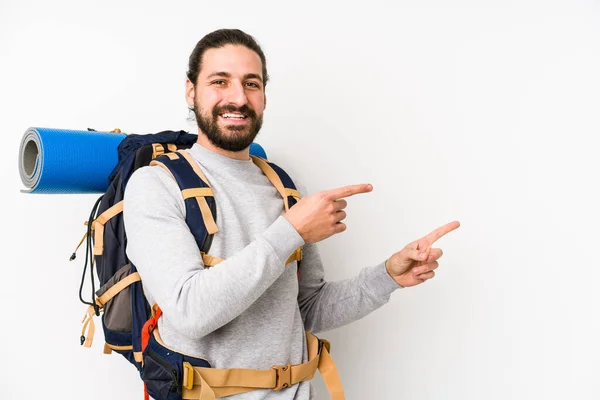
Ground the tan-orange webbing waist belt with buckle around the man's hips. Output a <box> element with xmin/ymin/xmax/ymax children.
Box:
<box><xmin>182</xmin><ymin>332</ymin><xmax>345</xmax><ymax>400</ymax></box>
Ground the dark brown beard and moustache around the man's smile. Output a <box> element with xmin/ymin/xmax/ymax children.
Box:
<box><xmin>194</xmin><ymin>100</ymin><xmax>262</xmax><ymax>152</ymax></box>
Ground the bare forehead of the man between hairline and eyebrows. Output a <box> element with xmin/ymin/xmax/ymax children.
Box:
<box><xmin>200</xmin><ymin>45</ymin><xmax>262</xmax><ymax>76</ymax></box>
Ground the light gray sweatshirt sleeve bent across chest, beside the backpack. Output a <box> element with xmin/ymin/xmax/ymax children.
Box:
<box><xmin>123</xmin><ymin>167</ymin><xmax>304</xmax><ymax>339</ymax></box>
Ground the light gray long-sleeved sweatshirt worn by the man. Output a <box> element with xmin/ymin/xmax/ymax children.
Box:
<box><xmin>123</xmin><ymin>144</ymin><xmax>400</xmax><ymax>400</ymax></box>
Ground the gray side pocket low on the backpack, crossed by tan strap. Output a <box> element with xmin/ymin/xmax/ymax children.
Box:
<box><xmin>96</xmin><ymin>263</ymin><xmax>131</xmax><ymax>332</ymax></box>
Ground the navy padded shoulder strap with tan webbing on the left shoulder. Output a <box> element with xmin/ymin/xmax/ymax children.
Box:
<box><xmin>150</xmin><ymin>151</ymin><xmax>219</xmax><ymax>253</ymax></box>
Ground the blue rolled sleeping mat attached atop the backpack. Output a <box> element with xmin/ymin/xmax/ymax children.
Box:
<box><xmin>19</xmin><ymin>127</ymin><xmax>267</xmax><ymax>194</ymax></box>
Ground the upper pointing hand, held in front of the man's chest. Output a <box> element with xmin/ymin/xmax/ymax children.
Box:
<box><xmin>284</xmin><ymin>184</ymin><xmax>373</xmax><ymax>243</ymax></box>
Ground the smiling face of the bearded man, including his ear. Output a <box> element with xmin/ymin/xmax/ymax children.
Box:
<box><xmin>186</xmin><ymin>45</ymin><xmax>266</xmax><ymax>151</ymax></box>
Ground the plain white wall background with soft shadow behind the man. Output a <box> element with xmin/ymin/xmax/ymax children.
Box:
<box><xmin>0</xmin><ymin>0</ymin><xmax>600</xmax><ymax>400</ymax></box>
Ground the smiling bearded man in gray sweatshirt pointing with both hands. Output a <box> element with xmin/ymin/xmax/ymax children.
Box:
<box><xmin>124</xmin><ymin>30</ymin><xmax>459</xmax><ymax>399</ymax></box>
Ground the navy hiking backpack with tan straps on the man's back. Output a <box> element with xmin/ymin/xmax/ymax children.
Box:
<box><xmin>71</xmin><ymin>131</ymin><xmax>343</xmax><ymax>400</ymax></box>
